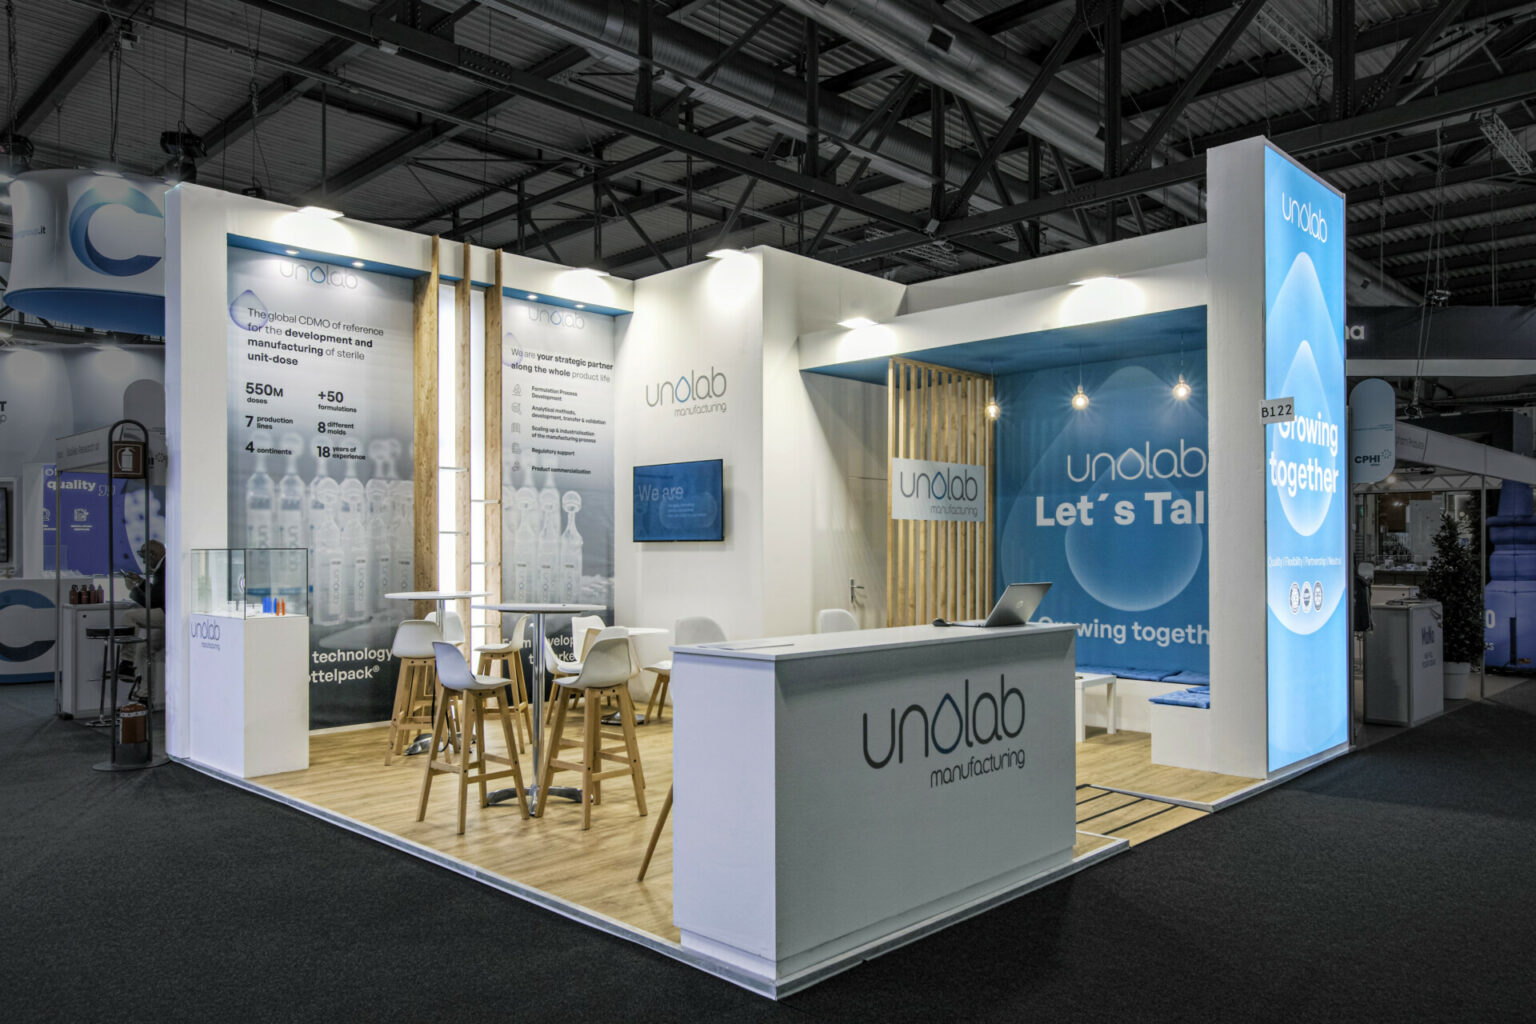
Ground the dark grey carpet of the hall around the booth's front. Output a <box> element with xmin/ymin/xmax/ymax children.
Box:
<box><xmin>0</xmin><ymin>683</ymin><xmax>1536</xmax><ymax>1024</ymax></box>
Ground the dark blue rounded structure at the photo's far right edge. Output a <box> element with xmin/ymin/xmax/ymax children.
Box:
<box><xmin>1484</xmin><ymin>481</ymin><xmax>1536</xmax><ymax>668</ymax></box>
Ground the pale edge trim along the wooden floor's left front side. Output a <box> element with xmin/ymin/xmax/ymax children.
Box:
<box><xmin>170</xmin><ymin>757</ymin><xmax>774</xmax><ymax>998</ymax></box>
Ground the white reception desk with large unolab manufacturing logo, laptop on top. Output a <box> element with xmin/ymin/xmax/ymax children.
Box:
<box><xmin>671</xmin><ymin>625</ymin><xmax>1075</xmax><ymax>995</ymax></box>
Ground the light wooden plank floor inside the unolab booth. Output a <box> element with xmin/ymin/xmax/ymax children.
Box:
<box><xmin>255</xmin><ymin>715</ymin><xmax>1234</xmax><ymax>941</ymax></box>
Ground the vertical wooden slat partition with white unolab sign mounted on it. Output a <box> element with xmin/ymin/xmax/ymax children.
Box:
<box><xmin>885</xmin><ymin>359</ymin><xmax>994</xmax><ymax>626</ymax></box>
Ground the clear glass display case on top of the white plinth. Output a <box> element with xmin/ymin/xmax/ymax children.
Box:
<box><xmin>192</xmin><ymin>548</ymin><xmax>309</xmax><ymax>619</ymax></box>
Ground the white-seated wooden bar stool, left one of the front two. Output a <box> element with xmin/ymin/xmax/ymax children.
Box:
<box><xmin>416</xmin><ymin>640</ymin><xmax>528</xmax><ymax>835</ymax></box>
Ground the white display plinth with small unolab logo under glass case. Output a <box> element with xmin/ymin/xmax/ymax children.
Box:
<box><xmin>187</xmin><ymin>616</ymin><xmax>309</xmax><ymax>778</ymax></box>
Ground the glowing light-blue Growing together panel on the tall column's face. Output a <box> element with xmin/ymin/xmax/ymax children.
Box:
<box><xmin>1264</xmin><ymin>149</ymin><xmax>1349</xmax><ymax>771</ymax></box>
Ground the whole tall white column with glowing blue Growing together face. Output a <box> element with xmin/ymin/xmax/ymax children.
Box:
<box><xmin>1207</xmin><ymin>138</ymin><xmax>1349</xmax><ymax>778</ymax></box>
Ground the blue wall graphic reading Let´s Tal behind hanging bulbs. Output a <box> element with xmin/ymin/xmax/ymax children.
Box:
<box><xmin>995</xmin><ymin>354</ymin><xmax>1210</xmax><ymax>674</ymax></box>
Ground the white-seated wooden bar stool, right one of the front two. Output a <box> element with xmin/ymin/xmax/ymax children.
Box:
<box><xmin>535</xmin><ymin>629</ymin><xmax>645</xmax><ymax>829</ymax></box>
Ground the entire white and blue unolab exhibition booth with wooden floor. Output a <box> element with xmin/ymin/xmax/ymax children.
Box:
<box><xmin>5</xmin><ymin>138</ymin><xmax>1350</xmax><ymax>996</ymax></box>
